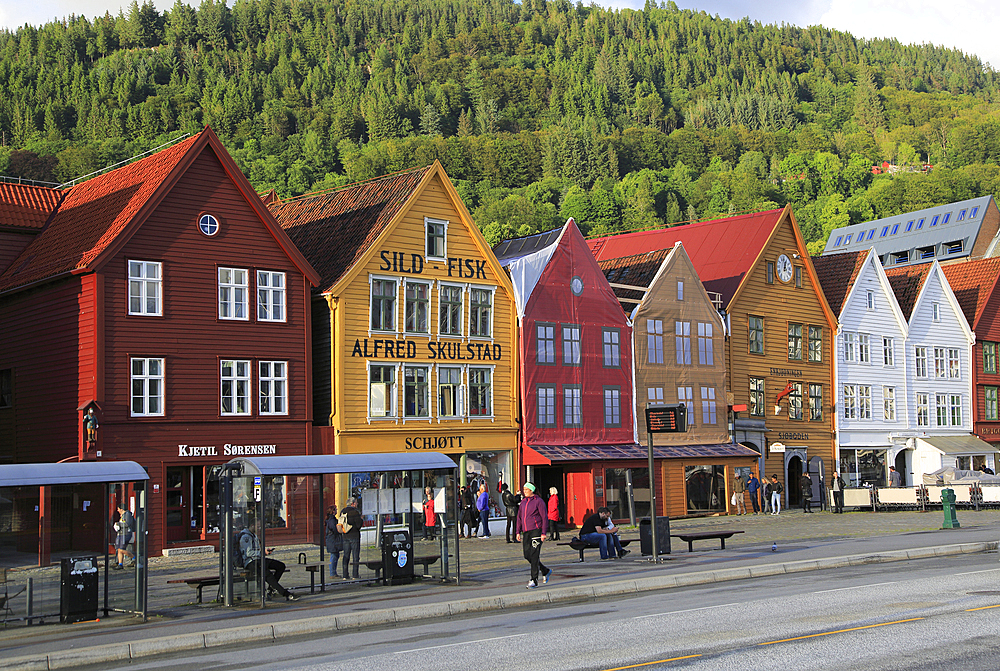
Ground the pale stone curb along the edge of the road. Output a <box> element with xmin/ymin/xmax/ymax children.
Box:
<box><xmin>0</xmin><ymin>541</ymin><xmax>1000</xmax><ymax>671</ymax></box>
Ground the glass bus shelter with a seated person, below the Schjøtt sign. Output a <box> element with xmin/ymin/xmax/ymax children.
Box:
<box><xmin>219</xmin><ymin>452</ymin><xmax>461</xmax><ymax>608</ymax></box>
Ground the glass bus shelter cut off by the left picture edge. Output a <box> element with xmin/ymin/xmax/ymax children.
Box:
<box><xmin>0</xmin><ymin>461</ymin><xmax>149</xmax><ymax>626</ymax></box>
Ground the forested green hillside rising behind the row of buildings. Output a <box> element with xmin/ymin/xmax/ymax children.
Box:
<box><xmin>0</xmin><ymin>0</ymin><xmax>1000</xmax><ymax>252</ymax></box>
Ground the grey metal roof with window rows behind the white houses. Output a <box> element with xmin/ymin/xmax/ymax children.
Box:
<box><xmin>823</xmin><ymin>196</ymin><xmax>993</xmax><ymax>266</ymax></box>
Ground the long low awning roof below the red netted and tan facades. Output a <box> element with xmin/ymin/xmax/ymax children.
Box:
<box><xmin>522</xmin><ymin>443</ymin><xmax>760</xmax><ymax>466</ymax></box>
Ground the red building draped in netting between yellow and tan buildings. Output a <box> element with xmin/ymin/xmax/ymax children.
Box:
<box><xmin>494</xmin><ymin>219</ymin><xmax>636</xmax><ymax>524</ymax></box>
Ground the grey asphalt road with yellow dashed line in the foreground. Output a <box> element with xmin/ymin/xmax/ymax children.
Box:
<box><xmin>74</xmin><ymin>553</ymin><xmax>1000</xmax><ymax>671</ymax></box>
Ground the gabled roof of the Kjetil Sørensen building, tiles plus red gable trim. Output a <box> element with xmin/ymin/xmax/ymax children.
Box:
<box><xmin>0</xmin><ymin>127</ymin><xmax>318</xmax><ymax>292</ymax></box>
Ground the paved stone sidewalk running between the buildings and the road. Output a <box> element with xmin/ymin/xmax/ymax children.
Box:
<box><xmin>0</xmin><ymin>510</ymin><xmax>1000</xmax><ymax>669</ymax></box>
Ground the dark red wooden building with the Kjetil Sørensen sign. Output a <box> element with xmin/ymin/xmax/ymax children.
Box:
<box><xmin>0</xmin><ymin>128</ymin><xmax>318</xmax><ymax>554</ymax></box>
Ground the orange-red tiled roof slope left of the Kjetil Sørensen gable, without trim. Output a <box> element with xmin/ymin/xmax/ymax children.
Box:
<box><xmin>0</xmin><ymin>133</ymin><xmax>201</xmax><ymax>291</ymax></box>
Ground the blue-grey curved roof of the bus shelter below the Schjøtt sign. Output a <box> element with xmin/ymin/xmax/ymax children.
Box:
<box><xmin>229</xmin><ymin>452</ymin><xmax>458</xmax><ymax>475</ymax></box>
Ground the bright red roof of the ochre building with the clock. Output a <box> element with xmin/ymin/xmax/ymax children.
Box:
<box><xmin>588</xmin><ymin>210</ymin><xmax>785</xmax><ymax>306</ymax></box>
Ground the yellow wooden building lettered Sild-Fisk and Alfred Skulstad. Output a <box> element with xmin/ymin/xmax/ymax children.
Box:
<box><xmin>270</xmin><ymin>161</ymin><xmax>519</xmax><ymax>501</ymax></box>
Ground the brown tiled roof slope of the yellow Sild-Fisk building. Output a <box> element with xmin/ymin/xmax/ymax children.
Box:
<box><xmin>268</xmin><ymin>164</ymin><xmax>434</xmax><ymax>293</ymax></box>
